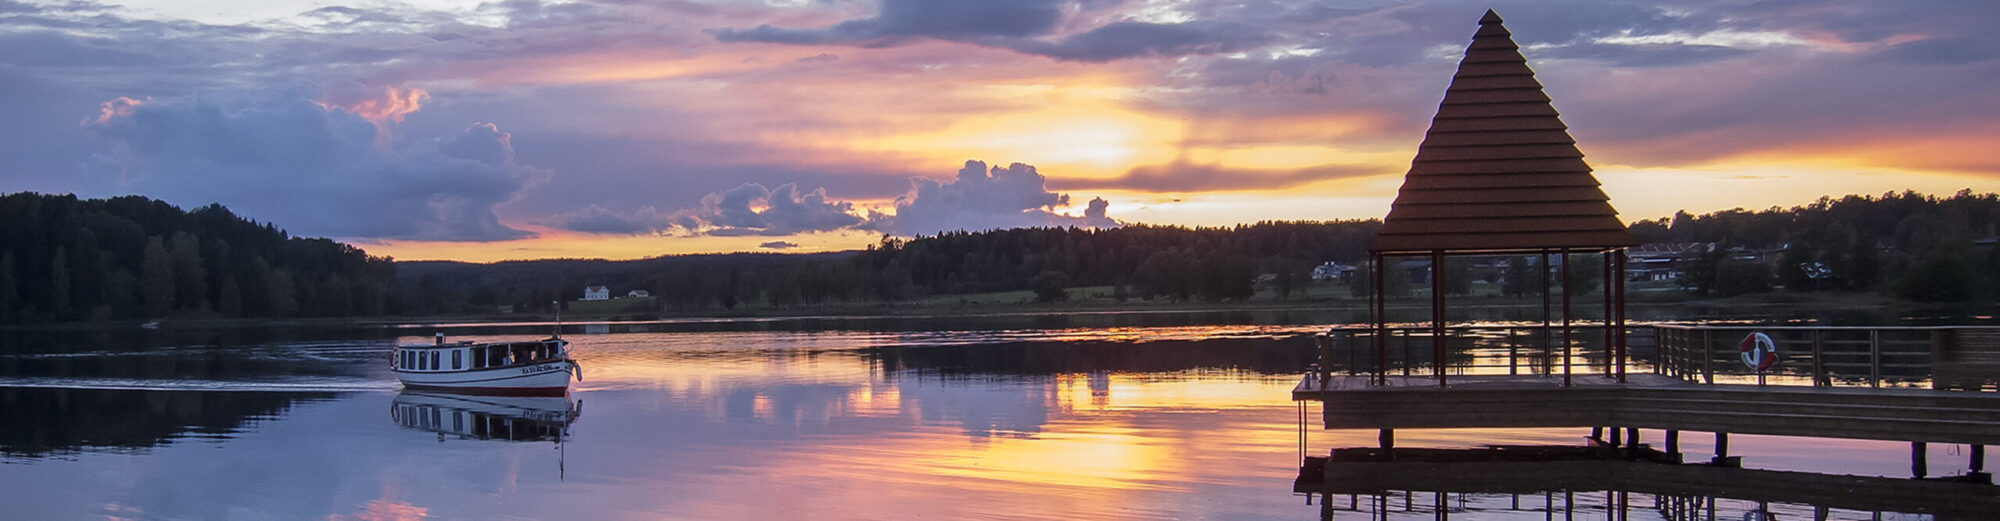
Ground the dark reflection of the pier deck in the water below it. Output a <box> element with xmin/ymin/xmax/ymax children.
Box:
<box><xmin>1292</xmin><ymin>447</ymin><xmax>2000</xmax><ymax>521</ymax></box>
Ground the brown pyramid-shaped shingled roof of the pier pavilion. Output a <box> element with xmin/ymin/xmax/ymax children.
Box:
<box><xmin>1374</xmin><ymin>10</ymin><xmax>1636</xmax><ymax>252</ymax></box>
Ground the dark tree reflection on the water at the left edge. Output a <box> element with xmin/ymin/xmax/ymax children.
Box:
<box><xmin>0</xmin><ymin>387</ymin><xmax>334</xmax><ymax>457</ymax></box>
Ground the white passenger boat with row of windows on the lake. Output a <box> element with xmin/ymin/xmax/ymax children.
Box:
<box><xmin>390</xmin><ymin>333</ymin><xmax>584</xmax><ymax>395</ymax></box>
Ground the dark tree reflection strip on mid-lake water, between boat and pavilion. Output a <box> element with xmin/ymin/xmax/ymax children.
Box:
<box><xmin>866</xmin><ymin>335</ymin><xmax>1314</xmax><ymax>377</ymax></box>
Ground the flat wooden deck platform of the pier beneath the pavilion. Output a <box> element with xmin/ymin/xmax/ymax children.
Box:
<box><xmin>1292</xmin><ymin>375</ymin><xmax>2000</xmax><ymax>445</ymax></box>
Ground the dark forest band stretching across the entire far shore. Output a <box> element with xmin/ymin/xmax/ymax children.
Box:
<box><xmin>0</xmin><ymin>190</ymin><xmax>2000</xmax><ymax>323</ymax></box>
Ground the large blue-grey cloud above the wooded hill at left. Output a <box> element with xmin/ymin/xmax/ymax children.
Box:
<box><xmin>84</xmin><ymin>92</ymin><xmax>546</xmax><ymax>240</ymax></box>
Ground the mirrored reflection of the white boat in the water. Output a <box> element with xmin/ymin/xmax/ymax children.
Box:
<box><xmin>388</xmin><ymin>391</ymin><xmax>584</xmax><ymax>445</ymax></box>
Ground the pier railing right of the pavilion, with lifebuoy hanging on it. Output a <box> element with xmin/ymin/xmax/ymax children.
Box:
<box><xmin>1650</xmin><ymin>325</ymin><xmax>2000</xmax><ymax>391</ymax></box>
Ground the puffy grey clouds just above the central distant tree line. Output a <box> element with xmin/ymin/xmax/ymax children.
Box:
<box><xmin>540</xmin><ymin>160</ymin><xmax>1120</xmax><ymax>238</ymax></box>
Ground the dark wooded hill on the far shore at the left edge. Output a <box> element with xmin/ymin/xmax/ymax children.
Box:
<box><xmin>0</xmin><ymin>192</ymin><xmax>396</xmax><ymax>323</ymax></box>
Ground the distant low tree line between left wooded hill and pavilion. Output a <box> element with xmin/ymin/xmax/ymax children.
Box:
<box><xmin>398</xmin><ymin>220</ymin><xmax>1380</xmax><ymax>315</ymax></box>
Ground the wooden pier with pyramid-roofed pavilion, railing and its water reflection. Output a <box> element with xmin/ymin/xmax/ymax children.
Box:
<box><xmin>1292</xmin><ymin>10</ymin><xmax>2000</xmax><ymax>519</ymax></box>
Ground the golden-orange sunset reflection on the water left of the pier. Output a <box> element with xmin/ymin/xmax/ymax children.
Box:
<box><xmin>552</xmin><ymin>329</ymin><xmax>1296</xmax><ymax>519</ymax></box>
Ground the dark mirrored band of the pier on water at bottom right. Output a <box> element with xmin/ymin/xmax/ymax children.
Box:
<box><xmin>1294</xmin><ymin>452</ymin><xmax>2000</xmax><ymax>521</ymax></box>
